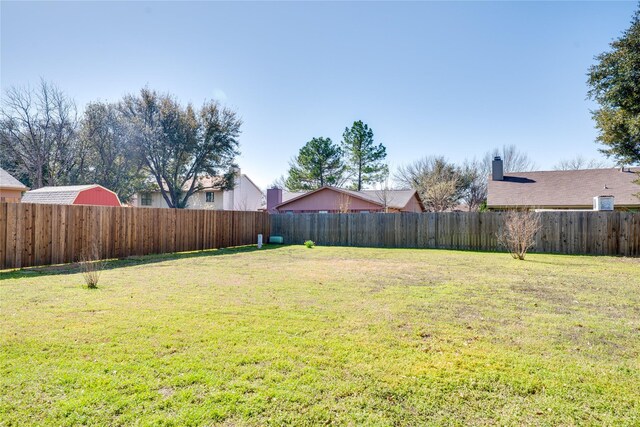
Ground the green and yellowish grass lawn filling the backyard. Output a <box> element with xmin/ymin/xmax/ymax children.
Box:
<box><xmin>0</xmin><ymin>246</ymin><xmax>640</xmax><ymax>426</ymax></box>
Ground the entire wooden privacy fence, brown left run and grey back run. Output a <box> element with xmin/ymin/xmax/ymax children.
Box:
<box><xmin>0</xmin><ymin>203</ymin><xmax>640</xmax><ymax>268</ymax></box>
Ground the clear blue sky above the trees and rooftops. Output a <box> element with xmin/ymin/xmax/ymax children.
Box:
<box><xmin>0</xmin><ymin>1</ymin><xmax>637</xmax><ymax>186</ymax></box>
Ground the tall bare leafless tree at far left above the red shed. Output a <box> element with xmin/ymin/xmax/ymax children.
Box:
<box><xmin>0</xmin><ymin>80</ymin><xmax>84</xmax><ymax>188</ymax></box>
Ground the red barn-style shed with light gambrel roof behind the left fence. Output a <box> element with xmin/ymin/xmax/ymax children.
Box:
<box><xmin>22</xmin><ymin>184</ymin><xmax>122</xmax><ymax>206</ymax></box>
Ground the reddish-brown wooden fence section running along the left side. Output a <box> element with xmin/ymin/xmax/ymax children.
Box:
<box><xmin>0</xmin><ymin>203</ymin><xmax>269</xmax><ymax>268</ymax></box>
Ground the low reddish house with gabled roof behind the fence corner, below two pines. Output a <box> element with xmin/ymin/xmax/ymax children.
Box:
<box><xmin>267</xmin><ymin>187</ymin><xmax>424</xmax><ymax>213</ymax></box>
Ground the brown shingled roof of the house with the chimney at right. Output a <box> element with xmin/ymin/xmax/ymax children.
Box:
<box><xmin>487</xmin><ymin>168</ymin><xmax>640</xmax><ymax>208</ymax></box>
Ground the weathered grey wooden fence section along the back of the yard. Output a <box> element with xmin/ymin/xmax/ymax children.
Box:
<box><xmin>271</xmin><ymin>212</ymin><xmax>640</xmax><ymax>256</ymax></box>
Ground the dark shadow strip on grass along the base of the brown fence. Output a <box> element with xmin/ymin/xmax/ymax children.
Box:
<box><xmin>0</xmin><ymin>245</ymin><xmax>284</xmax><ymax>280</ymax></box>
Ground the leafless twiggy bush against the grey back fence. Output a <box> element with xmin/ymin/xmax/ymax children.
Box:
<box><xmin>499</xmin><ymin>209</ymin><xmax>542</xmax><ymax>260</ymax></box>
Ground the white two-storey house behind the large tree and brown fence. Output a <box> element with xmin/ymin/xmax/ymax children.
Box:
<box><xmin>131</xmin><ymin>171</ymin><xmax>264</xmax><ymax>211</ymax></box>
